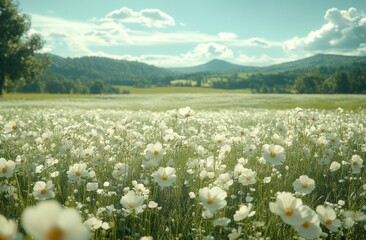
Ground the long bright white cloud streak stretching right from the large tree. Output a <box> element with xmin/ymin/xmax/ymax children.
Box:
<box><xmin>32</xmin><ymin>13</ymin><xmax>280</xmax><ymax>56</ymax></box>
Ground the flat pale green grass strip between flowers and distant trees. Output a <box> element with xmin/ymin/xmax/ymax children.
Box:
<box><xmin>0</xmin><ymin>92</ymin><xmax>366</xmax><ymax>111</ymax></box>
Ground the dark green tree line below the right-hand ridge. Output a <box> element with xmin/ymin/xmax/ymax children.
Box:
<box><xmin>189</xmin><ymin>63</ymin><xmax>366</xmax><ymax>94</ymax></box>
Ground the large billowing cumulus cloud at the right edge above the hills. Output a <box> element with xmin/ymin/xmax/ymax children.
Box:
<box><xmin>284</xmin><ymin>8</ymin><xmax>366</xmax><ymax>55</ymax></box>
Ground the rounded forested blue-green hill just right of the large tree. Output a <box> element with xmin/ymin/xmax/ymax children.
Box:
<box><xmin>47</xmin><ymin>55</ymin><xmax>174</xmax><ymax>85</ymax></box>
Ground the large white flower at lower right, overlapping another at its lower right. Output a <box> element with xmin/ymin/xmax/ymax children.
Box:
<box><xmin>269</xmin><ymin>192</ymin><xmax>309</xmax><ymax>226</ymax></box>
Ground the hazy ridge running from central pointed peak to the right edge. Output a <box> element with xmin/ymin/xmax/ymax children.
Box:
<box><xmin>170</xmin><ymin>54</ymin><xmax>366</xmax><ymax>73</ymax></box>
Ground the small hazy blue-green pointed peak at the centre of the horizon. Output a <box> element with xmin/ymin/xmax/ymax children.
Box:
<box><xmin>170</xmin><ymin>59</ymin><xmax>258</xmax><ymax>73</ymax></box>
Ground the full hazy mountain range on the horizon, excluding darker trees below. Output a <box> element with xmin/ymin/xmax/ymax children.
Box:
<box><xmin>38</xmin><ymin>54</ymin><xmax>366</xmax><ymax>86</ymax></box>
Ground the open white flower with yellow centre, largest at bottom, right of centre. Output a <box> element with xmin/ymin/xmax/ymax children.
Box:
<box><xmin>199</xmin><ymin>187</ymin><xmax>227</xmax><ymax>213</ymax></box>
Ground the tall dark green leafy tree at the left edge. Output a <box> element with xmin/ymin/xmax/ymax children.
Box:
<box><xmin>0</xmin><ymin>0</ymin><xmax>48</xmax><ymax>95</ymax></box>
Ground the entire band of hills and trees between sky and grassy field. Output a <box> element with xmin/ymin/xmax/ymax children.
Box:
<box><xmin>13</xmin><ymin>54</ymin><xmax>366</xmax><ymax>94</ymax></box>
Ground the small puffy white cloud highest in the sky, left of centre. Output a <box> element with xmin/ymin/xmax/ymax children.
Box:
<box><xmin>104</xmin><ymin>7</ymin><xmax>175</xmax><ymax>28</ymax></box>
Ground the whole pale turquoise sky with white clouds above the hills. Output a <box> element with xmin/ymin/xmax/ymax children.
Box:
<box><xmin>18</xmin><ymin>0</ymin><xmax>366</xmax><ymax>67</ymax></box>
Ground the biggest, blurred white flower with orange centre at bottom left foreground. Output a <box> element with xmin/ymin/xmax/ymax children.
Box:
<box><xmin>21</xmin><ymin>201</ymin><xmax>89</xmax><ymax>240</ymax></box>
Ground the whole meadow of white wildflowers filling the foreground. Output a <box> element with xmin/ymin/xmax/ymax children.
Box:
<box><xmin>0</xmin><ymin>103</ymin><xmax>366</xmax><ymax>240</ymax></box>
